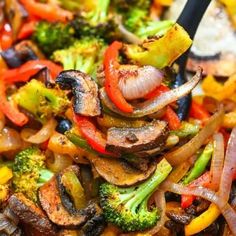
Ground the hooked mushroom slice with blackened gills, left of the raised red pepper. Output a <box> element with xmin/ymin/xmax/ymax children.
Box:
<box><xmin>56</xmin><ymin>70</ymin><xmax>101</xmax><ymax>116</ymax></box>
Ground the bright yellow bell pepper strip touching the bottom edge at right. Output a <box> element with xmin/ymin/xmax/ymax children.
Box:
<box><xmin>184</xmin><ymin>203</ymin><xmax>221</xmax><ymax>235</ymax></box>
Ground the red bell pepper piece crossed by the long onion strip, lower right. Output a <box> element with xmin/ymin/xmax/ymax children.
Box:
<box><xmin>181</xmin><ymin>171</ymin><xmax>211</xmax><ymax>209</ymax></box>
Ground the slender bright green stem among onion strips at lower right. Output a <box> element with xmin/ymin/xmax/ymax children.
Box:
<box><xmin>183</xmin><ymin>143</ymin><xmax>214</xmax><ymax>185</ymax></box>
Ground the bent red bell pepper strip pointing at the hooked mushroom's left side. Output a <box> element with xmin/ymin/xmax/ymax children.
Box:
<box><xmin>3</xmin><ymin>60</ymin><xmax>62</xmax><ymax>84</ymax></box>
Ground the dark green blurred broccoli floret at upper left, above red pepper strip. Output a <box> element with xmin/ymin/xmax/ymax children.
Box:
<box><xmin>33</xmin><ymin>21</ymin><xmax>74</xmax><ymax>56</ymax></box>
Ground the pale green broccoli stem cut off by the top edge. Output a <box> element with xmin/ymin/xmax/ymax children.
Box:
<box><xmin>90</xmin><ymin>0</ymin><xmax>110</xmax><ymax>25</ymax></box>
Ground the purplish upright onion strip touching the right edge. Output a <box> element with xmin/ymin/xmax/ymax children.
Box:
<box><xmin>219</xmin><ymin>127</ymin><xmax>236</xmax><ymax>203</ymax></box>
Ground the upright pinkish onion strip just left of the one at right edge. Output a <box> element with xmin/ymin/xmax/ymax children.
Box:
<box><xmin>210</xmin><ymin>133</ymin><xmax>224</xmax><ymax>191</ymax></box>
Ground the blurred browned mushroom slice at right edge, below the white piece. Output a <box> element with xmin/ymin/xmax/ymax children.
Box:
<box><xmin>187</xmin><ymin>53</ymin><xmax>236</xmax><ymax>77</ymax></box>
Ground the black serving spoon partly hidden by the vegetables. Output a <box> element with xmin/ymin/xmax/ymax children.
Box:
<box><xmin>173</xmin><ymin>0</ymin><xmax>211</xmax><ymax>120</ymax></box>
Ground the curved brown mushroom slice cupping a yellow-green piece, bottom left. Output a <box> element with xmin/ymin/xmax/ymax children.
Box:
<box><xmin>39</xmin><ymin>172</ymin><xmax>95</xmax><ymax>229</ymax></box>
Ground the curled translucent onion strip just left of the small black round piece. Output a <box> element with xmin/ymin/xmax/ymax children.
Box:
<box><xmin>21</xmin><ymin>119</ymin><xmax>57</xmax><ymax>144</ymax></box>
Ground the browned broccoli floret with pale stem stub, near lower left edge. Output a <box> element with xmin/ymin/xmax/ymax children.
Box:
<box><xmin>13</xmin><ymin>147</ymin><xmax>53</xmax><ymax>202</ymax></box>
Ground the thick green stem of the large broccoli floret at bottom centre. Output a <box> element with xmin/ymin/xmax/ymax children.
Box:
<box><xmin>125</xmin><ymin>159</ymin><xmax>172</xmax><ymax>210</ymax></box>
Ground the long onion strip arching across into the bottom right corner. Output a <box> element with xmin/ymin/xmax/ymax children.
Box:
<box><xmin>160</xmin><ymin>181</ymin><xmax>236</xmax><ymax>235</ymax></box>
